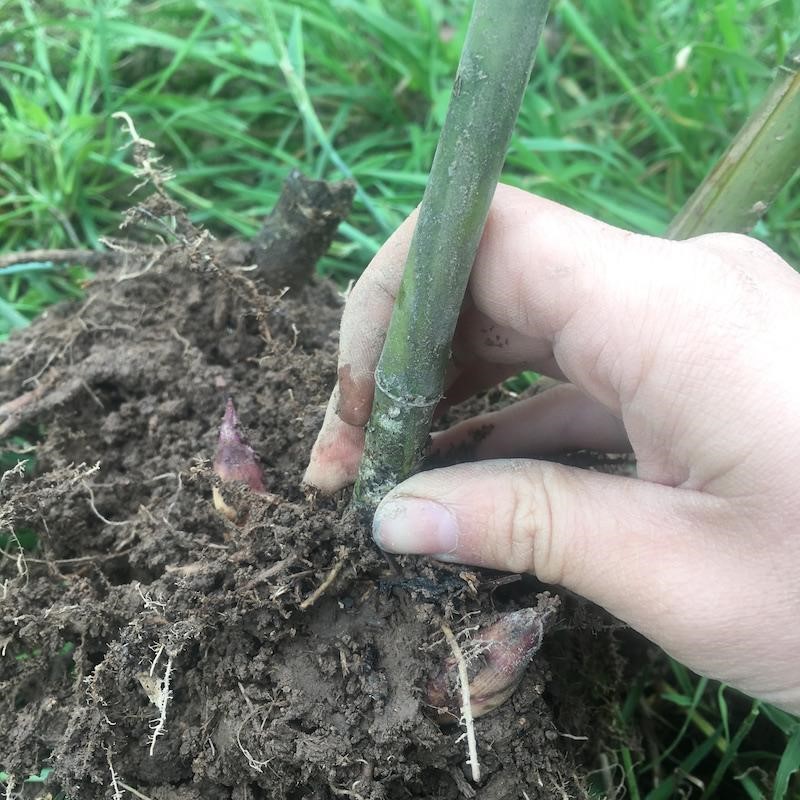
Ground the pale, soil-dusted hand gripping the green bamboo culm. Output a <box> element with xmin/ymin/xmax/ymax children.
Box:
<box><xmin>306</xmin><ymin>186</ymin><xmax>800</xmax><ymax>713</ymax></box>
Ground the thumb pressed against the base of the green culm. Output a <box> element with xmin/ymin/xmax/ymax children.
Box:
<box><xmin>373</xmin><ymin>461</ymin><xmax>800</xmax><ymax>703</ymax></box>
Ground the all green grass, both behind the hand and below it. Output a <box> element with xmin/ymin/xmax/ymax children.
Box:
<box><xmin>0</xmin><ymin>0</ymin><xmax>800</xmax><ymax>800</ymax></box>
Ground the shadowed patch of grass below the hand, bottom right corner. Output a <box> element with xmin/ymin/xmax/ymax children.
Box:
<box><xmin>617</xmin><ymin>659</ymin><xmax>800</xmax><ymax>800</ymax></box>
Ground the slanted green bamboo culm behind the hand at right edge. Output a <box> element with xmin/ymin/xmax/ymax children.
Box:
<box><xmin>667</xmin><ymin>40</ymin><xmax>800</xmax><ymax>239</ymax></box>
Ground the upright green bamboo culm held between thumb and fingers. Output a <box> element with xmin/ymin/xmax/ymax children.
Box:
<box><xmin>353</xmin><ymin>0</ymin><xmax>549</xmax><ymax>513</ymax></box>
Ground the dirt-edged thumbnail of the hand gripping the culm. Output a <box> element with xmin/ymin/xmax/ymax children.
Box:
<box><xmin>372</xmin><ymin>497</ymin><xmax>458</xmax><ymax>556</ymax></box>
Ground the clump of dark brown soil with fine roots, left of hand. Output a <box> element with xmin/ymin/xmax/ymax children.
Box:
<box><xmin>0</xmin><ymin>177</ymin><xmax>621</xmax><ymax>800</ymax></box>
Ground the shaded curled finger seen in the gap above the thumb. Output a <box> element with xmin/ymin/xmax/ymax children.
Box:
<box><xmin>432</xmin><ymin>384</ymin><xmax>630</xmax><ymax>460</ymax></box>
